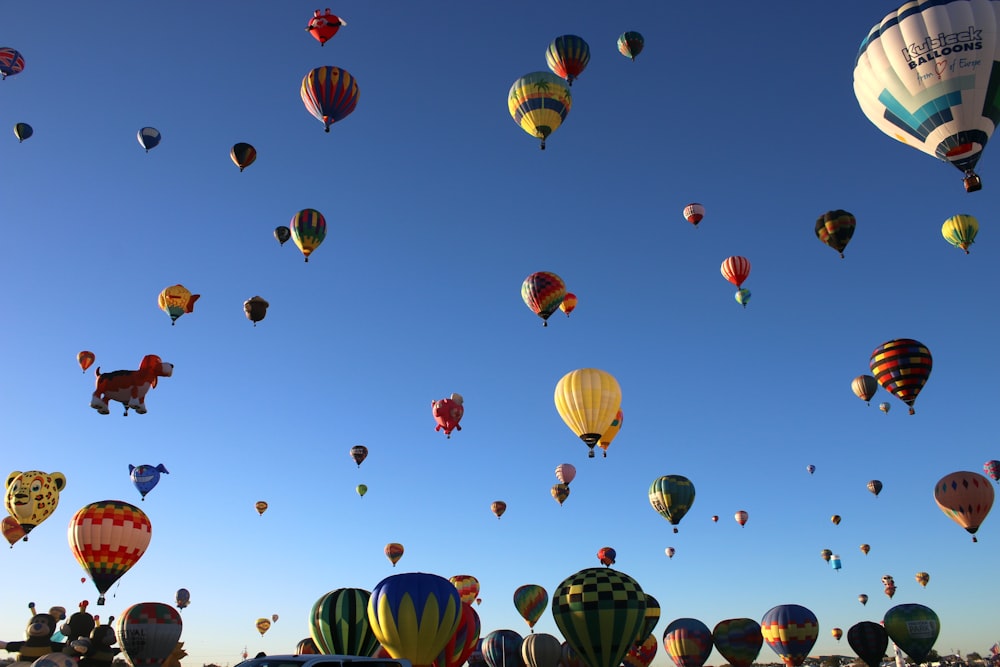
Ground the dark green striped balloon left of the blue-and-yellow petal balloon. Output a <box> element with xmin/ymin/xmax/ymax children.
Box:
<box><xmin>309</xmin><ymin>588</ymin><xmax>378</xmax><ymax>656</ymax></box>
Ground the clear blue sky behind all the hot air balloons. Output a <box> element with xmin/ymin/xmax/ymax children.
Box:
<box><xmin>0</xmin><ymin>0</ymin><xmax>1000</xmax><ymax>666</ymax></box>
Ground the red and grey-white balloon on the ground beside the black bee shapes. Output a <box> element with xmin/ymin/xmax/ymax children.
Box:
<box><xmin>119</xmin><ymin>602</ymin><xmax>186</xmax><ymax>667</ymax></box>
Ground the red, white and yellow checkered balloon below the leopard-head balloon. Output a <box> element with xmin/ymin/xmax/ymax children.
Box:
<box><xmin>69</xmin><ymin>500</ymin><xmax>153</xmax><ymax>604</ymax></box>
